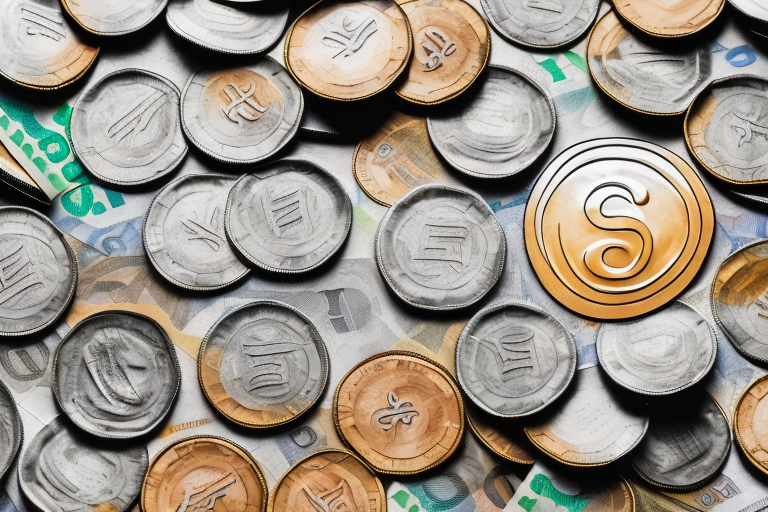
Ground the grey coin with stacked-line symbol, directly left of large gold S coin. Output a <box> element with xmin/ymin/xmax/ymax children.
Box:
<box><xmin>375</xmin><ymin>185</ymin><xmax>507</xmax><ymax>310</ymax></box>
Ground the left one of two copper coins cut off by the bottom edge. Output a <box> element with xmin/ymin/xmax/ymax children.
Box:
<box><xmin>141</xmin><ymin>436</ymin><xmax>267</xmax><ymax>512</ymax></box>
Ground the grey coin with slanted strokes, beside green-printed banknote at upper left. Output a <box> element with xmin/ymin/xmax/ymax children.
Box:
<box><xmin>71</xmin><ymin>69</ymin><xmax>187</xmax><ymax>186</ymax></box>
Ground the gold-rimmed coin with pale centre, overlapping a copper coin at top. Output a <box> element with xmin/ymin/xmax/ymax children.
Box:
<box><xmin>285</xmin><ymin>0</ymin><xmax>413</xmax><ymax>101</ymax></box>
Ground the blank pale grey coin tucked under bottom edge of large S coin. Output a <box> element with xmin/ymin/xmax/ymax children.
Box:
<box><xmin>597</xmin><ymin>302</ymin><xmax>717</xmax><ymax>395</ymax></box>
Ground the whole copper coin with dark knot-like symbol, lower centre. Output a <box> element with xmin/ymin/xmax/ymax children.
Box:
<box><xmin>333</xmin><ymin>351</ymin><xmax>464</xmax><ymax>475</ymax></box>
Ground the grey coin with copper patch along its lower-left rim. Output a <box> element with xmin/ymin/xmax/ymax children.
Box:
<box><xmin>197</xmin><ymin>300</ymin><xmax>330</xmax><ymax>428</ymax></box>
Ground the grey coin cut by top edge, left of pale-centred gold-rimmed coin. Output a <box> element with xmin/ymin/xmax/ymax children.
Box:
<box><xmin>165</xmin><ymin>0</ymin><xmax>289</xmax><ymax>54</ymax></box>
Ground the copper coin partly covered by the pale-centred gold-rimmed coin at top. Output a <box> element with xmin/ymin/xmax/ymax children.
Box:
<box><xmin>395</xmin><ymin>0</ymin><xmax>491</xmax><ymax>105</ymax></box>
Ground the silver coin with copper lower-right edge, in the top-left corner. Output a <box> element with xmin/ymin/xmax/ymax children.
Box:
<box><xmin>0</xmin><ymin>0</ymin><xmax>99</xmax><ymax>89</ymax></box>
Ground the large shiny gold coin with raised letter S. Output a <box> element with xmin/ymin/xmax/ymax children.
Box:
<box><xmin>525</xmin><ymin>138</ymin><xmax>714</xmax><ymax>319</ymax></box>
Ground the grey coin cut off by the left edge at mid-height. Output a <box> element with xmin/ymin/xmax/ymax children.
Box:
<box><xmin>0</xmin><ymin>206</ymin><xmax>77</xmax><ymax>336</ymax></box>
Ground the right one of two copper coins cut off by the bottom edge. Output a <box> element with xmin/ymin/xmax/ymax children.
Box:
<box><xmin>268</xmin><ymin>449</ymin><xmax>387</xmax><ymax>512</ymax></box>
